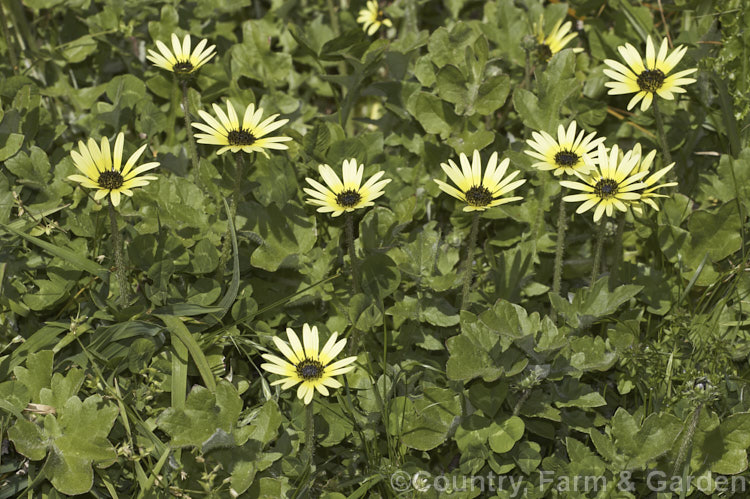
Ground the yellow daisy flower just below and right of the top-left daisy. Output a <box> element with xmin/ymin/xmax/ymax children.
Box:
<box><xmin>193</xmin><ymin>100</ymin><xmax>292</xmax><ymax>157</ymax></box>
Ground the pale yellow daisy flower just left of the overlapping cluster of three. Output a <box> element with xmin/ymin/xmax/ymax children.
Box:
<box><xmin>434</xmin><ymin>149</ymin><xmax>526</xmax><ymax>211</ymax></box>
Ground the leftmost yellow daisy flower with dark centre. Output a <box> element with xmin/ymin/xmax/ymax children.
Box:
<box><xmin>68</xmin><ymin>133</ymin><xmax>159</xmax><ymax>206</ymax></box>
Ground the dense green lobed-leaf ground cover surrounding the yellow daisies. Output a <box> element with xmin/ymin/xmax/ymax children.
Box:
<box><xmin>0</xmin><ymin>0</ymin><xmax>750</xmax><ymax>498</ymax></box>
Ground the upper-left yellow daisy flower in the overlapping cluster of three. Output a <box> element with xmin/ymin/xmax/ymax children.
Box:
<box><xmin>524</xmin><ymin>121</ymin><xmax>605</xmax><ymax>176</ymax></box>
